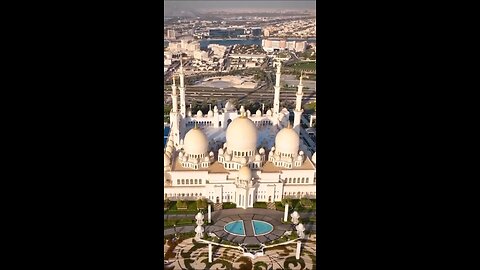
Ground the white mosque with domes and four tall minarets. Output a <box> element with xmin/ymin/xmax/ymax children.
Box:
<box><xmin>164</xmin><ymin>59</ymin><xmax>316</xmax><ymax>209</ymax></box>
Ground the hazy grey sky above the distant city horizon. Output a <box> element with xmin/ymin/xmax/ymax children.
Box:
<box><xmin>164</xmin><ymin>0</ymin><xmax>316</xmax><ymax>15</ymax></box>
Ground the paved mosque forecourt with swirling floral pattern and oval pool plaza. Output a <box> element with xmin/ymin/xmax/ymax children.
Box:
<box><xmin>164</xmin><ymin>208</ymin><xmax>316</xmax><ymax>270</ymax></box>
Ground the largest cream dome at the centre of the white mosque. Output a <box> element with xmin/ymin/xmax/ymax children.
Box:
<box><xmin>227</xmin><ymin>116</ymin><xmax>257</xmax><ymax>153</ymax></box>
